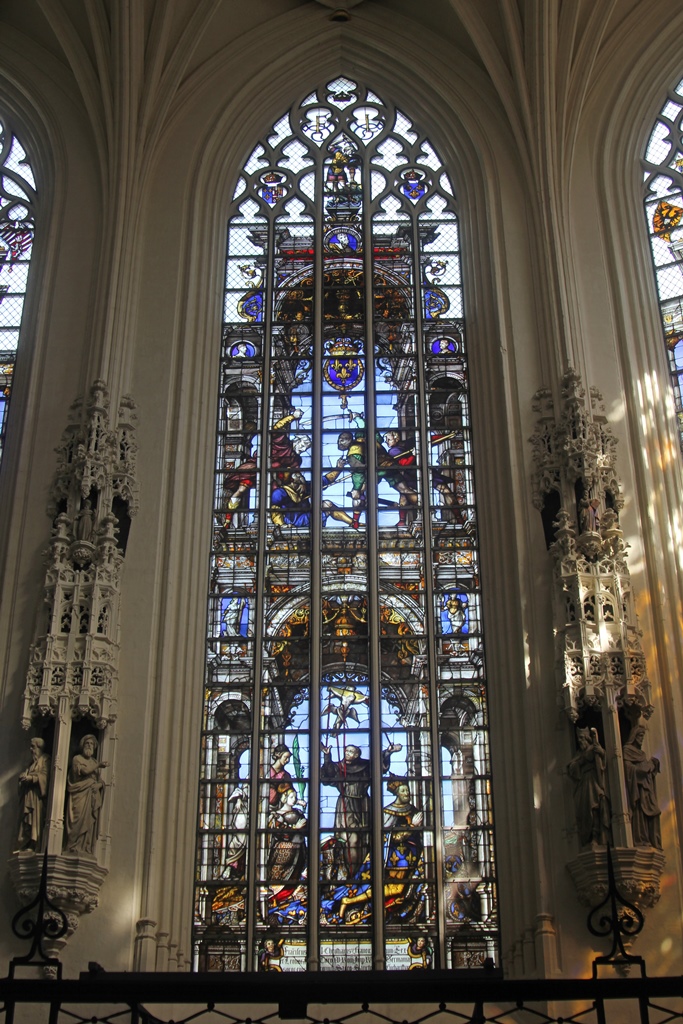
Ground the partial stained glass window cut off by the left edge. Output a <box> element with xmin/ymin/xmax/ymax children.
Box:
<box><xmin>0</xmin><ymin>114</ymin><xmax>36</xmax><ymax>462</ymax></box>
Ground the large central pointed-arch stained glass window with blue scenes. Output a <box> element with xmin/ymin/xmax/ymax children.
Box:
<box><xmin>195</xmin><ymin>78</ymin><xmax>498</xmax><ymax>971</ymax></box>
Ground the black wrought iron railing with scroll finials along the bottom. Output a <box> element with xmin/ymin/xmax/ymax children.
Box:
<box><xmin>0</xmin><ymin>851</ymin><xmax>683</xmax><ymax>1024</ymax></box>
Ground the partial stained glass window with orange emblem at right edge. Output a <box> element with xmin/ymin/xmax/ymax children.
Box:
<box><xmin>643</xmin><ymin>80</ymin><xmax>683</xmax><ymax>450</ymax></box>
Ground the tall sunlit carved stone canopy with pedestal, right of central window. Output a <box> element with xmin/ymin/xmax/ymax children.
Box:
<box><xmin>529</xmin><ymin>369</ymin><xmax>665</xmax><ymax>929</ymax></box>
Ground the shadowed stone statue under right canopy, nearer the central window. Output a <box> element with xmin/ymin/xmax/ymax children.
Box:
<box><xmin>567</xmin><ymin>729</ymin><xmax>611</xmax><ymax>846</ymax></box>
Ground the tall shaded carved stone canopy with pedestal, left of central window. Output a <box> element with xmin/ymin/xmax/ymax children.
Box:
<box><xmin>10</xmin><ymin>380</ymin><xmax>138</xmax><ymax>952</ymax></box>
